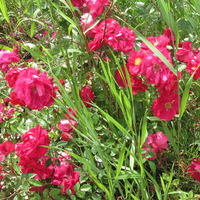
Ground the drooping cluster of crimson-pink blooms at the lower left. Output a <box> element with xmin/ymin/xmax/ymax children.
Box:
<box><xmin>16</xmin><ymin>125</ymin><xmax>79</xmax><ymax>194</ymax></box>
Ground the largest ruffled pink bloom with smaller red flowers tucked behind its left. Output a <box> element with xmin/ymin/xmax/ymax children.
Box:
<box><xmin>6</xmin><ymin>67</ymin><xmax>56</xmax><ymax>110</ymax></box>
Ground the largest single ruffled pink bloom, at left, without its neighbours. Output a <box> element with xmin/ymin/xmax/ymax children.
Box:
<box><xmin>14</xmin><ymin>67</ymin><xmax>56</xmax><ymax>110</ymax></box>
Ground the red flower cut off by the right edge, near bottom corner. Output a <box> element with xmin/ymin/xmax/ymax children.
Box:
<box><xmin>187</xmin><ymin>158</ymin><xmax>200</xmax><ymax>182</ymax></box>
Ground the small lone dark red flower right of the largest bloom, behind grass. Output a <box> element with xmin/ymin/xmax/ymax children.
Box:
<box><xmin>80</xmin><ymin>86</ymin><xmax>94</xmax><ymax>107</ymax></box>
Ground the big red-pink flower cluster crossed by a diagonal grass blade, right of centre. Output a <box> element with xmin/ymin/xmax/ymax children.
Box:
<box><xmin>115</xmin><ymin>28</ymin><xmax>181</xmax><ymax>120</ymax></box>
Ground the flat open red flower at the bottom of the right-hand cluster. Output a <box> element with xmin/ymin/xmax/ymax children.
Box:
<box><xmin>152</xmin><ymin>93</ymin><xmax>179</xmax><ymax>121</ymax></box>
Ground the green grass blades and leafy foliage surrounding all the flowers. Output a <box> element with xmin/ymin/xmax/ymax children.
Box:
<box><xmin>0</xmin><ymin>0</ymin><xmax>200</xmax><ymax>200</ymax></box>
